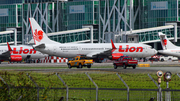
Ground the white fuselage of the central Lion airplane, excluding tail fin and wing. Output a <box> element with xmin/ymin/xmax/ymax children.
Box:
<box><xmin>35</xmin><ymin>43</ymin><xmax>157</xmax><ymax>58</ymax></box>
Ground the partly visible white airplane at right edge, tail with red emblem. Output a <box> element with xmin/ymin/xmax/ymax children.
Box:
<box><xmin>158</xmin><ymin>32</ymin><xmax>180</xmax><ymax>57</ymax></box>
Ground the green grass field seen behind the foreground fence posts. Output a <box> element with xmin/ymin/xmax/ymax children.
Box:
<box><xmin>0</xmin><ymin>70</ymin><xmax>180</xmax><ymax>101</ymax></box>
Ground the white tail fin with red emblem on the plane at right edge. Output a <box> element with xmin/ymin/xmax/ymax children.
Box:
<box><xmin>158</xmin><ymin>32</ymin><xmax>177</xmax><ymax>50</ymax></box>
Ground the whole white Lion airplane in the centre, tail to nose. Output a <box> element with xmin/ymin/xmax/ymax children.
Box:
<box><xmin>29</xmin><ymin>18</ymin><xmax>157</xmax><ymax>60</ymax></box>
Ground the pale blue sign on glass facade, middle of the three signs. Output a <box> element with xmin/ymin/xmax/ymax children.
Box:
<box><xmin>69</xmin><ymin>5</ymin><xmax>85</xmax><ymax>14</ymax></box>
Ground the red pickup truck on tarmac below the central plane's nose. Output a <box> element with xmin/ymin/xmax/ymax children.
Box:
<box><xmin>113</xmin><ymin>56</ymin><xmax>138</xmax><ymax>69</ymax></box>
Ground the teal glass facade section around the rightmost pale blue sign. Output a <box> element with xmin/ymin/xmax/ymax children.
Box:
<box><xmin>141</xmin><ymin>0</ymin><xmax>178</xmax><ymax>28</ymax></box>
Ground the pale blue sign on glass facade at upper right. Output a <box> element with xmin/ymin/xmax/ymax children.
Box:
<box><xmin>151</xmin><ymin>1</ymin><xmax>168</xmax><ymax>10</ymax></box>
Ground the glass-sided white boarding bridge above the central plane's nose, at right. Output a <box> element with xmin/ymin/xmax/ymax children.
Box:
<box><xmin>105</xmin><ymin>23</ymin><xmax>177</xmax><ymax>43</ymax></box>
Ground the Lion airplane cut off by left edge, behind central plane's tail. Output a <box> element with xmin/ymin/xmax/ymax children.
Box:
<box><xmin>0</xmin><ymin>42</ymin><xmax>48</xmax><ymax>63</ymax></box>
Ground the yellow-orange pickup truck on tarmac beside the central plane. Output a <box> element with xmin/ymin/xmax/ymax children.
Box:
<box><xmin>67</xmin><ymin>56</ymin><xmax>93</xmax><ymax>68</ymax></box>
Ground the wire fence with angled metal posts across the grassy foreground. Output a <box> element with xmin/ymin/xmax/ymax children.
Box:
<box><xmin>0</xmin><ymin>72</ymin><xmax>180</xmax><ymax>101</ymax></box>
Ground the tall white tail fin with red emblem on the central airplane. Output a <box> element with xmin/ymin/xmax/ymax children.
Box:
<box><xmin>29</xmin><ymin>18</ymin><xmax>57</xmax><ymax>45</ymax></box>
